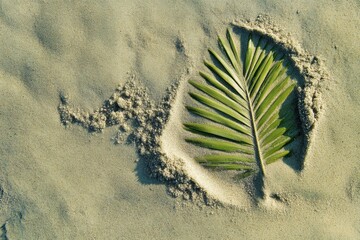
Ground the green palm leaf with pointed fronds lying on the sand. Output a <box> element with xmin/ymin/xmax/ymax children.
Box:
<box><xmin>184</xmin><ymin>30</ymin><xmax>299</xmax><ymax>177</ymax></box>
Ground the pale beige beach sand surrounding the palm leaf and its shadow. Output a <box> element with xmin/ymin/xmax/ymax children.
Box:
<box><xmin>0</xmin><ymin>0</ymin><xmax>360</xmax><ymax>239</ymax></box>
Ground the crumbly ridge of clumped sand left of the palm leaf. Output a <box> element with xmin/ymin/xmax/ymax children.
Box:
<box><xmin>58</xmin><ymin>72</ymin><xmax>216</xmax><ymax>205</ymax></box>
